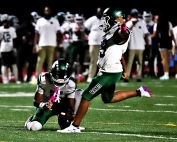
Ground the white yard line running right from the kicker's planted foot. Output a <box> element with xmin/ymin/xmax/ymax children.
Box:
<box><xmin>81</xmin><ymin>132</ymin><xmax>177</xmax><ymax>140</ymax></box>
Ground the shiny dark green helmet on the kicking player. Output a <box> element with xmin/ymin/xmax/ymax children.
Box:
<box><xmin>99</xmin><ymin>8</ymin><xmax>125</xmax><ymax>32</ymax></box>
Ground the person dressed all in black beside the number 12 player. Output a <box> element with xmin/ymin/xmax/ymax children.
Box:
<box><xmin>17</xmin><ymin>14</ymin><xmax>37</xmax><ymax>82</ymax></box>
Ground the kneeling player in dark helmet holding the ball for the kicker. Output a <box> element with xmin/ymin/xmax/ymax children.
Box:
<box><xmin>25</xmin><ymin>60</ymin><xmax>85</xmax><ymax>131</ymax></box>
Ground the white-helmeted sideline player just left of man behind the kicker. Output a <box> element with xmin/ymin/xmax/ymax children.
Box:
<box><xmin>69</xmin><ymin>14</ymin><xmax>85</xmax><ymax>80</ymax></box>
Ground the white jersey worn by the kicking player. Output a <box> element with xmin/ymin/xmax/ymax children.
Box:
<box><xmin>97</xmin><ymin>28</ymin><xmax>130</xmax><ymax>73</ymax></box>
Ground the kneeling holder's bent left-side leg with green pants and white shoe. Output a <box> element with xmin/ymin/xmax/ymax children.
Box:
<box><xmin>25</xmin><ymin>108</ymin><xmax>54</xmax><ymax>131</ymax></box>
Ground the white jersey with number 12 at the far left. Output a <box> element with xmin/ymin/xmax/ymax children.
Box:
<box><xmin>0</xmin><ymin>26</ymin><xmax>17</xmax><ymax>52</ymax></box>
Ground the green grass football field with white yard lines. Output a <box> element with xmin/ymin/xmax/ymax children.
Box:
<box><xmin>0</xmin><ymin>79</ymin><xmax>177</xmax><ymax>142</ymax></box>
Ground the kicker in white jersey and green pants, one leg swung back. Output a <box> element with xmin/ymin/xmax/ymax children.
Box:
<box><xmin>57</xmin><ymin>8</ymin><xmax>152</xmax><ymax>133</ymax></box>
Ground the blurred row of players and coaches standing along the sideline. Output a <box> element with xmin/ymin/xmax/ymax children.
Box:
<box><xmin>0</xmin><ymin>7</ymin><xmax>177</xmax><ymax>84</ymax></box>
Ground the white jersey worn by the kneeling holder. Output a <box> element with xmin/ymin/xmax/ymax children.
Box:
<box><xmin>36</xmin><ymin>72</ymin><xmax>76</xmax><ymax>102</ymax></box>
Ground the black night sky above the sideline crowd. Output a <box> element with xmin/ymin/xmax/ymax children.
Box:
<box><xmin>0</xmin><ymin>0</ymin><xmax>177</xmax><ymax>21</ymax></box>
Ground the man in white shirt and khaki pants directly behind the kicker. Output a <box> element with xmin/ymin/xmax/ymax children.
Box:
<box><xmin>84</xmin><ymin>8</ymin><xmax>104</xmax><ymax>83</ymax></box>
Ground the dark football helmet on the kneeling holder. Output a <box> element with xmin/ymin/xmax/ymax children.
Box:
<box><xmin>49</xmin><ymin>59</ymin><xmax>70</xmax><ymax>88</ymax></box>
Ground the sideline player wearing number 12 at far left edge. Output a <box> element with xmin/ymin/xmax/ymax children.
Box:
<box><xmin>0</xmin><ymin>14</ymin><xmax>19</xmax><ymax>84</ymax></box>
